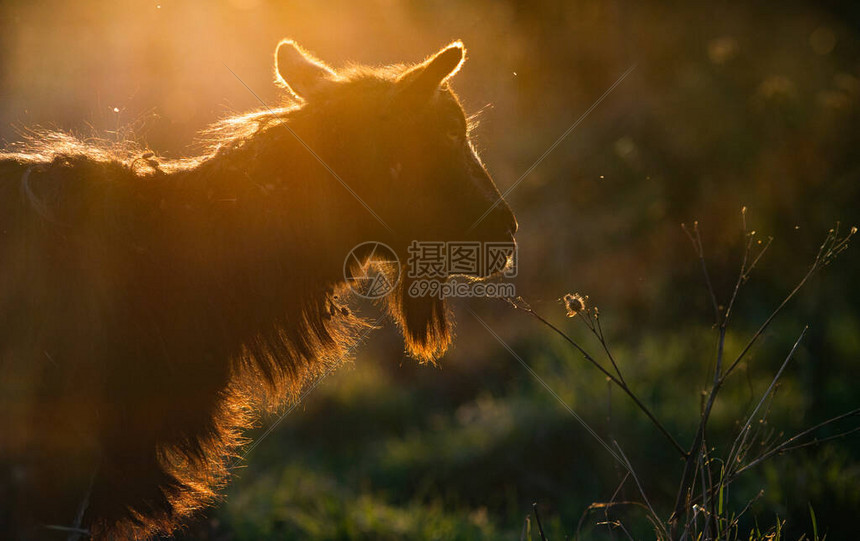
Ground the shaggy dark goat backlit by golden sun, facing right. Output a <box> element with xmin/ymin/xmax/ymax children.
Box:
<box><xmin>0</xmin><ymin>41</ymin><xmax>516</xmax><ymax>539</ymax></box>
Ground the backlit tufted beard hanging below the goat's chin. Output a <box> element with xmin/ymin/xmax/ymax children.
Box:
<box><xmin>387</xmin><ymin>276</ymin><xmax>453</xmax><ymax>362</ymax></box>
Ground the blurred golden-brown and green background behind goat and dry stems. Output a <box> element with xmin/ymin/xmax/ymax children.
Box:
<box><xmin>0</xmin><ymin>0</ymin><xmax>860</xmax><ymax>540</ymax></box>
